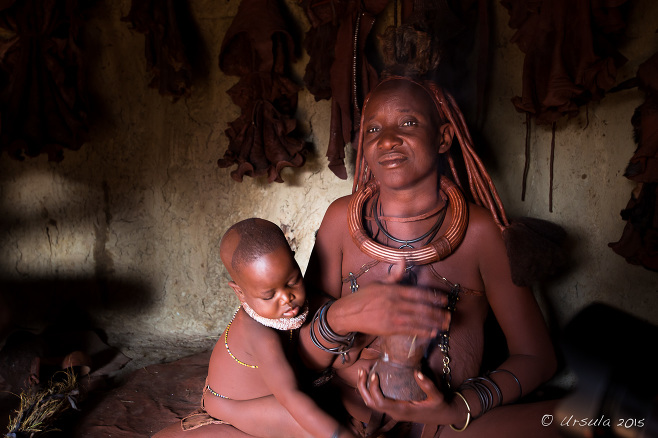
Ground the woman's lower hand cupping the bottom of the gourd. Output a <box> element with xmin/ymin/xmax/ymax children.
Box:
<box><xmin>357</xmin><ymin>369</ymin><xmax>466</xmax><ymax>424</ymax></box>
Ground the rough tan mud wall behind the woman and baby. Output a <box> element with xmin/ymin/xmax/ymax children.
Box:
<box><xmin>0</xmin><ymin>0</ymin><xmax>658</xmax><ymax>370</ymax></box>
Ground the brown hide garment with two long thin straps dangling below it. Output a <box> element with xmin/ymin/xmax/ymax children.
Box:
<box><xmin>501</xmin><ymin>0</ymin><xmax>628</xmax><ymax>211</ymax></box>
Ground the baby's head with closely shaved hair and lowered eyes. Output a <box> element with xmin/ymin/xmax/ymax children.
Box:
<box><xmin>219</xmin><ymin>218</ymin><xmax>306</xmax><ymax>319</ymax></box>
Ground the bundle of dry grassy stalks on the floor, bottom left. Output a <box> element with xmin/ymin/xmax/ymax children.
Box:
<box><xmin>5</xmin><ymin>370</ymin><xmax>80</xmax><ymax>438</ymax></box>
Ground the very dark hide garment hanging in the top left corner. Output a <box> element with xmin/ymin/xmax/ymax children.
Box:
<box><xmin>0</xmin><ymin>0</ymin><xmax>88</xmax><ymax>161</ymax></box>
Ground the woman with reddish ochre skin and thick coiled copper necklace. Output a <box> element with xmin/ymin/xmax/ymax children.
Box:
<box><xmin>290</xmin><ymin>24</ymin><xmax>559</xmax><ymax>438</ymax></box>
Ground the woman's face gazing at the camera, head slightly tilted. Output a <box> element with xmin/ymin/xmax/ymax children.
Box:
<box><xmin>363</xmin><ymin>80</ymin><xmax>439</xmax><ymax>189</ymax></box>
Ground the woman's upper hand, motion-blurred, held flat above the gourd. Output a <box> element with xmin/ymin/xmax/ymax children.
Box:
<box><xmin>327</xmin><ymin>263</ymin><xmax>450</xmax><ymax>338</ymax></box>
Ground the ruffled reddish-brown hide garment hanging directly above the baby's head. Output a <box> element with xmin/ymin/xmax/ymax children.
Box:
<box><xmin>217</xmin><ymin>0</ymin><xmax>306</xmax><ymax>182</ymax></box>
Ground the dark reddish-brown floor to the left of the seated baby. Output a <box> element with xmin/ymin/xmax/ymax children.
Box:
<box><xmin>0</xmin><ymin>332</ymin><xmax>210</xmax><ymax>438</ymax></box>
